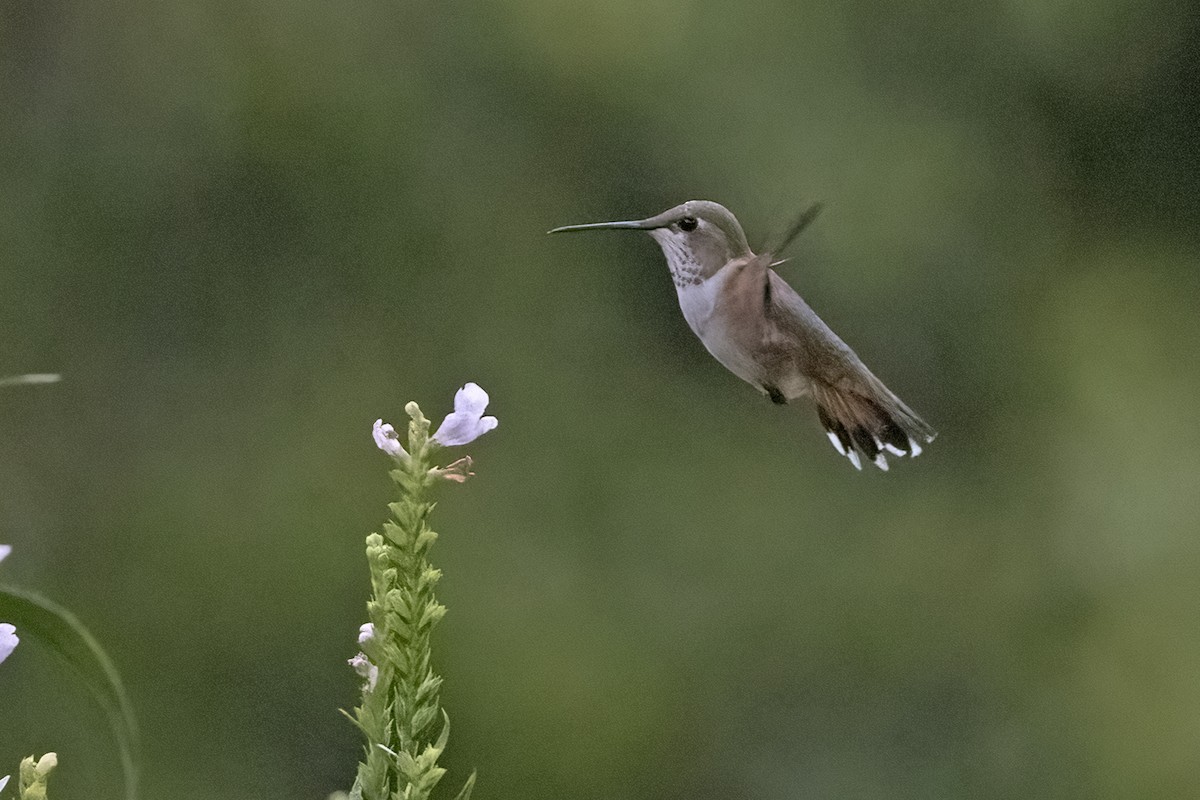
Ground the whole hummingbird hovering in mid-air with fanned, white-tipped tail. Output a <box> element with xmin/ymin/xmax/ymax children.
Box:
<box><xmin>550</xmin><ymin>200</ymin><xmax>937</xmax><ymax>470</ymax></box>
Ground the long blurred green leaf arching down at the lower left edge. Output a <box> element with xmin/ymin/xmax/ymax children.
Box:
<box><xmin>0</xmin><ymin>585</ymin><xmax>138</xmax><ymax>800</ymax></box>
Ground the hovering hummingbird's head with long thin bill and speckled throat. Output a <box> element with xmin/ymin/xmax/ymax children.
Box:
<box><xmin>550</xmin><ymin>200</ymin><xmax>752</xmax><ymax>287</ymax></box>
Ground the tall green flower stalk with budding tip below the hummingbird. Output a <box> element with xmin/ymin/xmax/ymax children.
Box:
<box><xmin>350</xmin><ymin>403</ymin><xmax>475</xmax><ymax>800</ymax></box>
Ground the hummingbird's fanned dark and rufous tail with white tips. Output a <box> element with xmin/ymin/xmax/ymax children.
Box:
<box><xmin>812</xmin><ymin>375</ymin><xmax>937</xmax><ymax>470</ymax></box>
